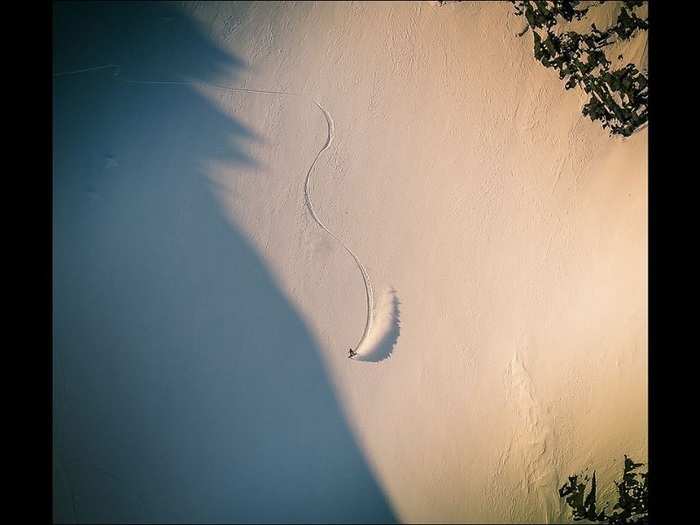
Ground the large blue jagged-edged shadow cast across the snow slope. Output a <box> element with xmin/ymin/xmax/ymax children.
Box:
<box><xmin>53</xmin><ymin>2</ymin><xmax>396</xmax><ymax>523</ymax></box>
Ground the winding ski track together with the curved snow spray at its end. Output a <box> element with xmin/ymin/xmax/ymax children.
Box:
<box><xmin>53</xmin><ymin>64</ymin><xmax>399</xmax><ymax>362</ymax></box>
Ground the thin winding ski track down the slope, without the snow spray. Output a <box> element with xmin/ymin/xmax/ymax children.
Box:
<box><xmin>53</xmin><ymin>64</ymin><xmax>374</xmax><ymax>361</ymax></box>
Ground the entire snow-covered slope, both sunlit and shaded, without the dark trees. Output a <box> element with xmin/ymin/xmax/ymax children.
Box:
<box><xmin>53</xmin><ymin>2</ymin><xmax>647</xmax><ymax>523</ymax></box>
